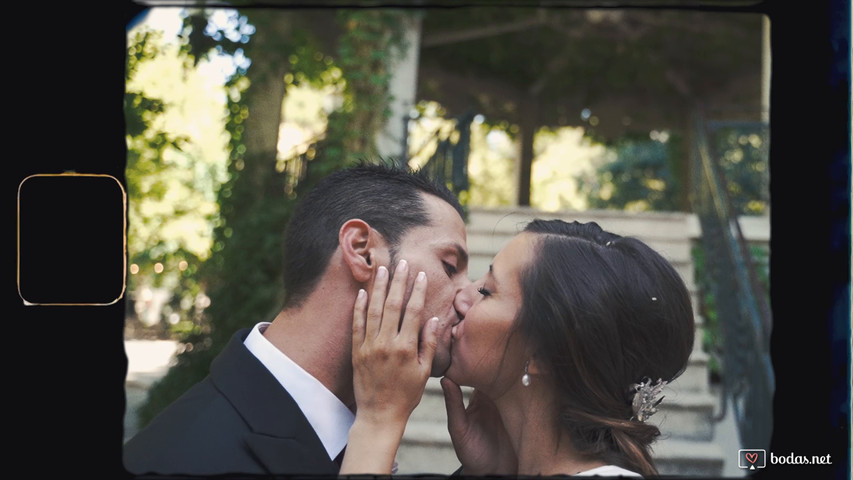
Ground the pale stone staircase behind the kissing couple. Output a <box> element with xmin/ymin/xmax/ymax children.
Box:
<box><xmin>397</xmin><ymin>208</ymin><xmax>737</xmax><ymax>477</ymax></box>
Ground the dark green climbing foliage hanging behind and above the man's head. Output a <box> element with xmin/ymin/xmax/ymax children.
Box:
<box><xmin>139</xmin><ymin>9</ymin><xmax>407</xmax><ymax>425</ymax></box>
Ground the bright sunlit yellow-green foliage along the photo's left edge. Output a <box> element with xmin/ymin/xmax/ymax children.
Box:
<box><xmin>124</xmin><ymin>30</ymin><xmax>225</xmax><ymax>342</ymax></box>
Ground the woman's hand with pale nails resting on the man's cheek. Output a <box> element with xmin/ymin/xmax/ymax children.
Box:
<box><xmin>341</xmin><ymin>261</ymin><xmax>438</xmax><ymax>474</ymax></box>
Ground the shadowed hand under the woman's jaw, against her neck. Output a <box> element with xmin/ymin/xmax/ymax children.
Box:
<box><xmin>441</xmin><ymin>377</ymin><xmax>518</xmax><ymax>476</ymax></box>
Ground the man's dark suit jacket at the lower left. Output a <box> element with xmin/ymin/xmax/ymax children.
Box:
<box><xmin>124</xmin><ymin>329</ymin><xmax>338</xmax><ymax>475</ymax></box>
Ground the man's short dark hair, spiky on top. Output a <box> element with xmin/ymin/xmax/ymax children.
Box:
<box><xmin>284</xmin><ymin>163</ymin><xmax>465</xmax><ymax>306</ymax></box>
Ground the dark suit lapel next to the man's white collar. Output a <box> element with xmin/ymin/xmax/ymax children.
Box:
<box><xmin>210</xmin><ymin>329</ymin><xmax>338</xmax><ymax>474</ymax></box>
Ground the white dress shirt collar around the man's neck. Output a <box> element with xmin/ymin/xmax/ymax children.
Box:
<box><xmin>243</xmin><ymin>322</ymin><xmax>355</xmax><ymax>459</ymax></box>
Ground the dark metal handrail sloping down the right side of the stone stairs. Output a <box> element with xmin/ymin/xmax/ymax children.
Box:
<box><xmin>692</xmin><ymin>110</ymin><xmax>775</xmax><ymax>449</ymax></box>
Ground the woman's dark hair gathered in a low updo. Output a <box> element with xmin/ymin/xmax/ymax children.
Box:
<box><xmin>518</xmin><ymin>219</ymin><xmax>695</xmax><ymax>475</ymax></box>
